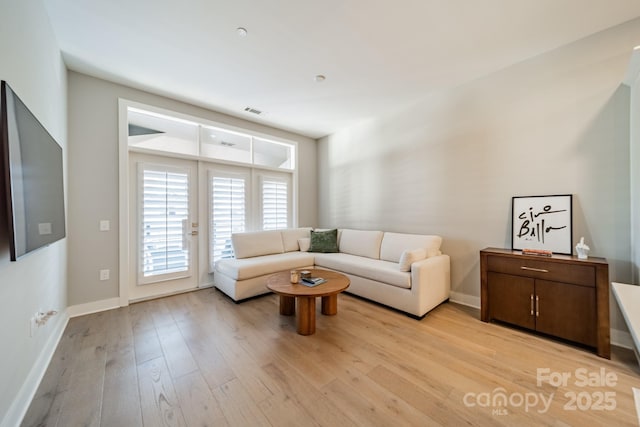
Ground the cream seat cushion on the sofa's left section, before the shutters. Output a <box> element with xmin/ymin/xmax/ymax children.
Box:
<box><xmin>216</xmin><ymin>251</ymin><xmax>313</xmax><ymax>280</ymax></box>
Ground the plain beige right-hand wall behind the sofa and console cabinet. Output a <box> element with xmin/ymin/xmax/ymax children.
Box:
<box><xmin>318</xmin><ymin>20</ymin><xmax>640</xmax><ymax>329</ymax></box>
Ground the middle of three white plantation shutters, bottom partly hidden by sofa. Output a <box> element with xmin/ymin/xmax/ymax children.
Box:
<box><xmin>209</xmin><ymin>172</ymin><xmax>247</xmax><ymax>272</ymax></box>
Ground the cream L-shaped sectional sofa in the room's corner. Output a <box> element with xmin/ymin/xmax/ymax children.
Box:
<box><xmin>213</xmin><ymin>228</ymin><xmax>450</xmax><ymax>317</ymax></box>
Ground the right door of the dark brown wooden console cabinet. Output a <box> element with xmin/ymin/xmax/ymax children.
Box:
<box><xmin>536</xmin><ymin>280</ymin><xmax>596</xmax><ymax>346</ymax></box>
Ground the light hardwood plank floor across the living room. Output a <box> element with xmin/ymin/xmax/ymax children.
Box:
<box><xmin>23</xmin><ymin>289</ymin><xmax>640</xmax><ymax>427</ymax></box>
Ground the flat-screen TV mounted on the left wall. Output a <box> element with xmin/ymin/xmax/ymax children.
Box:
<box><xmin>0</xmin><ymin>81</ymin><xmax>66</xmax><ymax>261</ymax></box>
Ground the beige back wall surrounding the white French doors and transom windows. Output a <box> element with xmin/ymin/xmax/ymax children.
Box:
<box><xmin>68</xmin><ymin>71</ymin><xmax>317</xmax><ymax>306</ymax></box>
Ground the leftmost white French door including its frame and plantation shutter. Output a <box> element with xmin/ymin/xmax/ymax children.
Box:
<box><xmin>128</xmin><ymin>153</ymin><xmax>199</xmax><ymax>301</ymax></box>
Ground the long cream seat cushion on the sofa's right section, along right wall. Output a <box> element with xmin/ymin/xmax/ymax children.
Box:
<box><xmin>315</xmin><ymin>253</ymin><xmax>411</xmax><ymax>289</ymax></box>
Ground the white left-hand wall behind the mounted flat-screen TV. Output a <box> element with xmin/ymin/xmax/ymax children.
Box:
<box><xmin>0</xmin><ymin>0</ymin><xmax>67</xmax><ymax>426</ymax></box>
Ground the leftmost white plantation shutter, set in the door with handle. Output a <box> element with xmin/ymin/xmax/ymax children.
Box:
<box><xmin>138</xmin><ymin>164</ymin><xmax>190</xmax><ymax>284</ymax></box>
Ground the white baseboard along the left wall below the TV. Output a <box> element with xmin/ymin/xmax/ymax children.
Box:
<box><xmin>0</xmin><ymin>312</ymin><xmax>69</xmax><ymax>427</ymax></box>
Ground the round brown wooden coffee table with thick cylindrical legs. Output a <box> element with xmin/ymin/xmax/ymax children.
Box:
<box><xmin>267</xmin><ymin>269</ymin><xmax>350</xmax><ymax>335</ymax></box>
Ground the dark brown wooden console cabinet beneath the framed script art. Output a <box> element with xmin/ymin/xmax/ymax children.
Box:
<box><xmin>480</xmin><ymin>248</ymin><xmax>611</xmax><ymax>359</ymax></box>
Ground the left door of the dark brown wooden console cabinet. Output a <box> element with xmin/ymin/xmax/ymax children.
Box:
<box><xmin>487</xmin><ymin>272</ymin><xmax>535</xmax><ymax>329</ymax></box>
